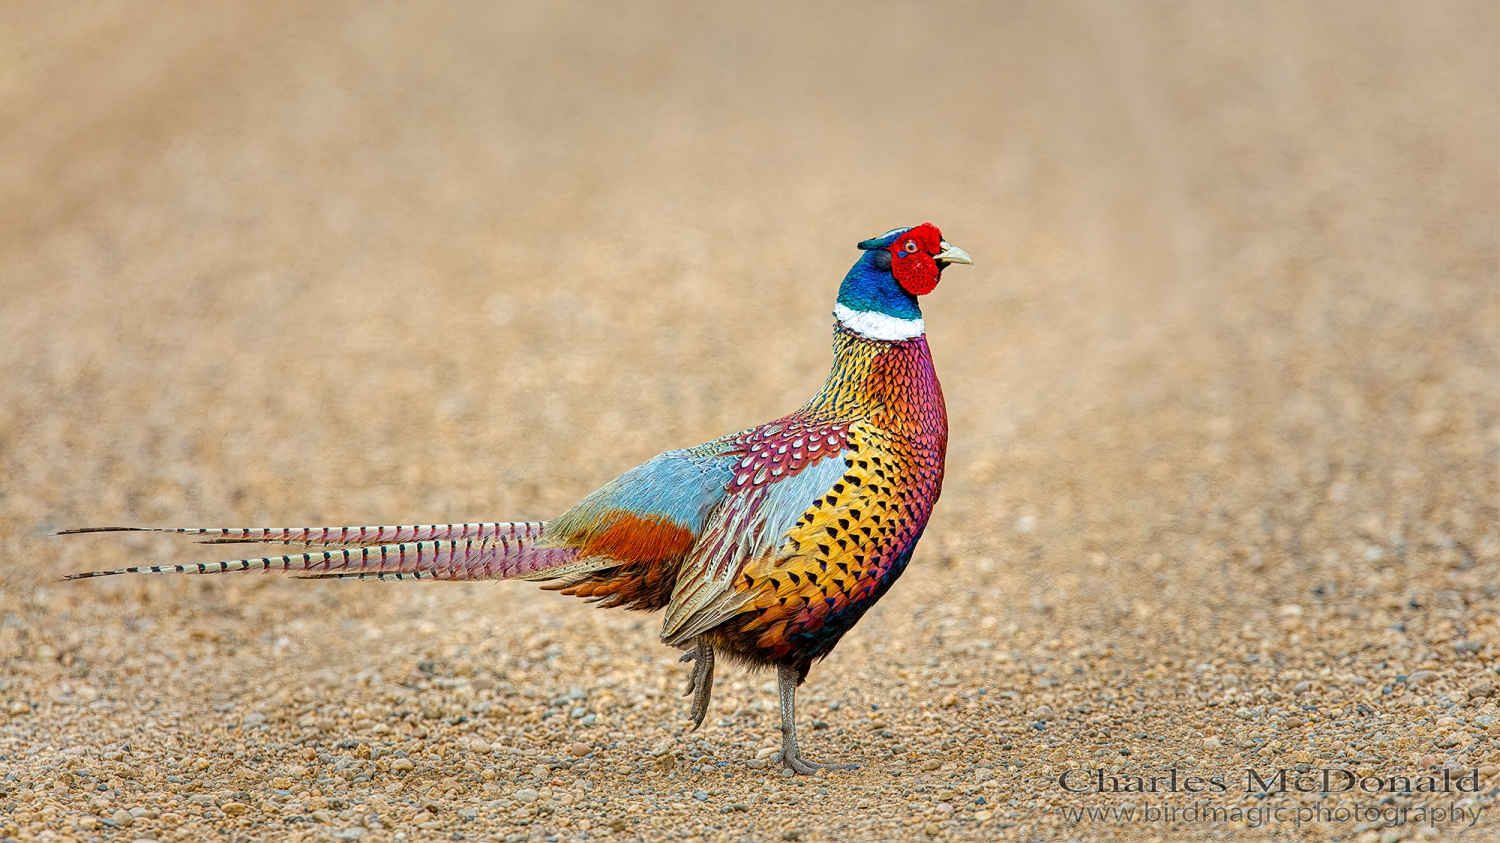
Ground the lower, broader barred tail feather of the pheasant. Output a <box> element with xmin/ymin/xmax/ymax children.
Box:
<box><xmin>63</xmin><ymin>522</ymin><xmax>581</xmax><ymax>581</ymax></box>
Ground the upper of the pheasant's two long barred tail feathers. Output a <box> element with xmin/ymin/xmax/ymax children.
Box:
<box><xmin>59</xmin><ymin>521</ymin><xmax>534</xmax><ymax>548</ymax></box>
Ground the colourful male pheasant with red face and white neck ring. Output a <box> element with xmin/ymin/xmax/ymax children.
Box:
<box><xmin>66</xmin><ymin>222</ymin><xmax>972</xmax><ymax>774</ymax></box>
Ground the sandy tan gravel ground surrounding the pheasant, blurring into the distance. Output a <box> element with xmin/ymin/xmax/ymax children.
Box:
<box><xmin>0</xmin><ymin>0</ymin><xmax>1500</xmax><ymax>843</ymax></box>
